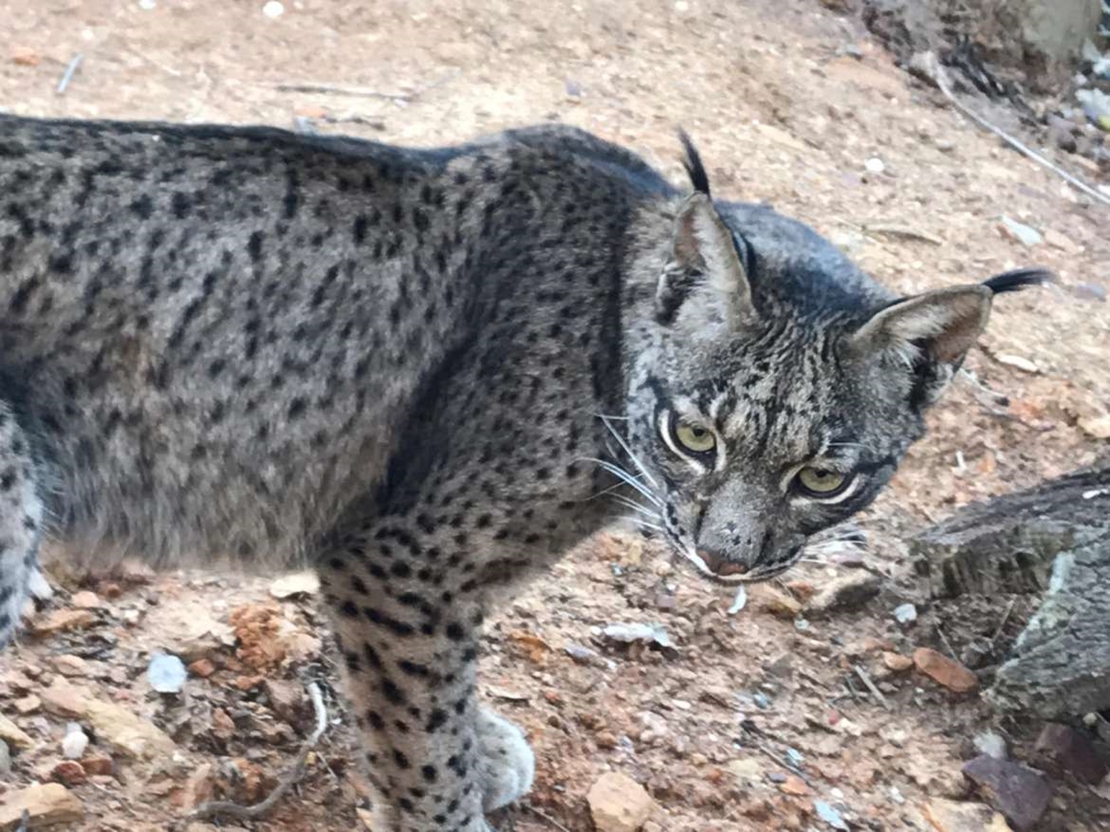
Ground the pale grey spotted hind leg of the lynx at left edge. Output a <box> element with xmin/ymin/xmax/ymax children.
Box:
<box><xmin>0</xmin><ymin>402</ymin><xmax>42</xmax><ymax>648</ymax></box>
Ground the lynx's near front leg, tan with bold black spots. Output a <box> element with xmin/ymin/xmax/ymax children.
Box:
<box><xmin>320</xmin><ymin>543</ymin><xmax>490</xmax><ymax>832</ymax></box>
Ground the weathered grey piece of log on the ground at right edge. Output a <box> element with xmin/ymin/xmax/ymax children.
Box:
<box><xmin>910</xmin><ymin>459</ymin><xmax>1110</xmax><ymax>719</ymax></box>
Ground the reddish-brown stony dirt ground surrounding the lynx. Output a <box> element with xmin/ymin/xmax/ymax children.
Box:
<box><xmin>0</xmin><ymin>0</ymin><xmax>1110</xmax><ymax>832</ymax></box>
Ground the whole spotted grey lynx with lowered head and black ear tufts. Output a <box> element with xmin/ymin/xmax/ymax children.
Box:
<box><xmin>0</xmin><ymin>118</ymin><xmax>1042</xmax><ymax>832</ymax></box>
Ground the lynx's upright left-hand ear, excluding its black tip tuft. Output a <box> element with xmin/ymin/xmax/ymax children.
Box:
<box><xmin>655</xmin><ymin>193</ymin><xmax>755</xmax><ymax>332</ymax></box>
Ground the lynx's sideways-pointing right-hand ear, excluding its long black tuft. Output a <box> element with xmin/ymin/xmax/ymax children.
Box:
<box><xmin>848</xmin><ymin>286</ymin><xmax>992</xmax><ymax>407</ymax></box>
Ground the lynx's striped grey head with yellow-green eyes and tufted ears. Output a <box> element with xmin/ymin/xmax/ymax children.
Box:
<box><xmin>625</xmin><ymin>136</ymin><xmax>1049</xmax><ymax>582</ymax></box>
